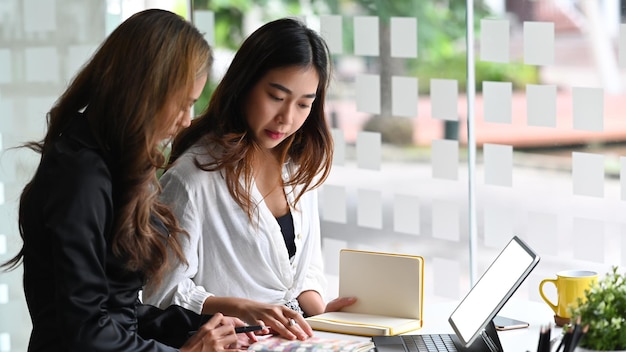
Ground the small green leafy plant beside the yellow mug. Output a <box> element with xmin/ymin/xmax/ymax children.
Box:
<box><xmin>572</xmin><ymin>266</ymin><xmax>626</xmax><ymax>351</ymax></box>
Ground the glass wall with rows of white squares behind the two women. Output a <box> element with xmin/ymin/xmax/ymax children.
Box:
<box><xmin>0</xmin><ymin>0</ymin><xmax>626</xmax><ymax>351</ymax></box>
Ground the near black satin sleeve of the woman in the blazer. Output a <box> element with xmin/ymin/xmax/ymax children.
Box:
<box><xmin>42</xmin><ymin>152</ymin><xmax>176</xmax><ymax>352</ymax></box>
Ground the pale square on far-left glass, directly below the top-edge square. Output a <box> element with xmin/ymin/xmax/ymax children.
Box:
<box><xmin>24</xmin><ymin>46</ymin><xmax>61</xmax><ymax>83</ymax></box>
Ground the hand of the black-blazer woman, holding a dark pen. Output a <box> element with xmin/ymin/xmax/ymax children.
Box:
<box><xmin>180</xmin><ymin>313</ymin><xmax>241</xmax><ymax>352</ymax></box>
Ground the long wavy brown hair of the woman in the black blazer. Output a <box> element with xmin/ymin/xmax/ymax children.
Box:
<box><xmin>4</xmin><ymin>9</ymin><xmax>213</xmax><ymax>288</ymax></box>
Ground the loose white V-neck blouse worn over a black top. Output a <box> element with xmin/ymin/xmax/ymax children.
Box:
<box><xmin>143</xmin><ymin>146</ymin><xmax>326</xmax><ymax>313</ymax></box>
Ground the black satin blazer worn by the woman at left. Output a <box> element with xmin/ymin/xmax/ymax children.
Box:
<box><xmin>20</xmin><ymin>115</ymin><xmax>210</xmax><ymax>352</ymax></box>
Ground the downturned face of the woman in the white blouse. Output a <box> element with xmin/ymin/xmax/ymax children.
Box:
<box><xmin>245</xmin><ymin>66</ymin><xmax>319</xmax><ymax>149</ymax></box>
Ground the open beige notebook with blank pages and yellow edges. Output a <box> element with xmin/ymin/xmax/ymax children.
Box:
<box><xmin>307</xmin><ymin>249</ymin><xmax>424</xmax><ymax>336</ymax></box>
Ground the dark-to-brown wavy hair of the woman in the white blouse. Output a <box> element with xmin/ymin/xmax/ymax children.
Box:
<box><xmin>170</xmin><ymin>18</ymin><xmax>333</xmax><ymax>219</ymax></box>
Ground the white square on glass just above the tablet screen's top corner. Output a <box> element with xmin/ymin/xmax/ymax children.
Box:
<box><xmin>483</xmin><ymin>204</ymin><xmax>514</xmax><ymax>248</ymax></box>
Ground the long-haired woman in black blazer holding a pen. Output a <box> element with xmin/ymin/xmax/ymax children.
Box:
<box><xmin>4</xmin><ymin>10</ymin><xmax>255</xmax><ymax>352</ymax></box>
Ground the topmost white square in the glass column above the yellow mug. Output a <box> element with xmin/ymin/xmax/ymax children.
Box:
<box><xmin>572</xmin><ymin>87</ymin><xmax>604</xmax><ymax>132</ymax></box>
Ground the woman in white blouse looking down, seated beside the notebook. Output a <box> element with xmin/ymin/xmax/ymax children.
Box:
<box><xmin>144</xmin><ymin>19</ymin><xmax>355</xmax><ymax>339</ymax></box>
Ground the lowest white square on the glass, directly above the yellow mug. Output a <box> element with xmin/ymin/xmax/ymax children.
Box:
<box><xmin>570</xmin><ymin>217</ymin><xmax>604</xmax><ymax>263</ymax></box>
